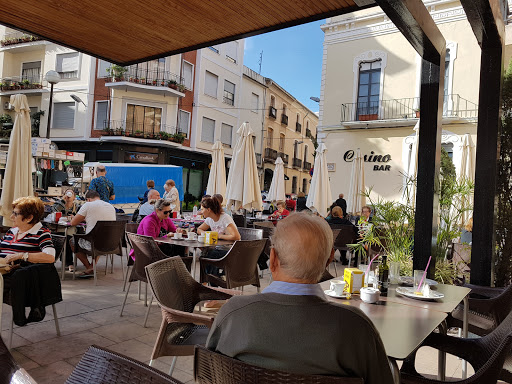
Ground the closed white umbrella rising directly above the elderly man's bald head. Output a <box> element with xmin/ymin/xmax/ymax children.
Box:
<box><xmin>306</xmin><ymin>143</ymin><xmax>332</xmax><ymax>217</ymax></box>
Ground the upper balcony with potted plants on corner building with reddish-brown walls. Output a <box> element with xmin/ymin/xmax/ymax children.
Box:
<box><xmin>105</xmin><ymin>64</ymin><xmax>186</xmax><ymax>97</ymax></box>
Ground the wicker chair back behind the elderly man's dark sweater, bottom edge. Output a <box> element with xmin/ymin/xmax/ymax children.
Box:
<box><xmin>194</xmin><ymin>345</ymin><xmax>364</xmax><ymax>384</ymax></box>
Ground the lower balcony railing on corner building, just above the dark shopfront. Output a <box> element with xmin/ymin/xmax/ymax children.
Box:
<box><xmin>102</xmin><ymin>120</ymin><xmax>187</xmax><ymax>144</ymax></box>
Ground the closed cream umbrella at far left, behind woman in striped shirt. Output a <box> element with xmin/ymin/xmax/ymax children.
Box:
<box><xmin>0</xmin><ymin>94</ymin><xmax>33</xmax><ymax>226</ymax></box>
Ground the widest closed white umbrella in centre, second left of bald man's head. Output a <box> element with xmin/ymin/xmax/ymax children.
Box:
<box><xmin>226</xmin><ymin>122</ymin><xmax>263</xmax><ymax>211</ymax></box>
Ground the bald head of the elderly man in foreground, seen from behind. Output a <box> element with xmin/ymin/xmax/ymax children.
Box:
<box><xmin>272</xmin><ymin>212</ymin><xmax>333</xmax><ymax>284</ymax></box>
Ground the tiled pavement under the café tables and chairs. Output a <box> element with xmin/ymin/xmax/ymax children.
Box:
<box><xmin>2</xmin><ymin>257</ymin><xmax>478</xmax><ymax>384</ymax></box>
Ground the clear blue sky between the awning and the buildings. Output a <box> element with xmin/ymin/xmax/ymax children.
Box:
<box><xmin>244</xmin><ymin>19</ymin><xmax>325</xmax><ymax>112</ymax></box>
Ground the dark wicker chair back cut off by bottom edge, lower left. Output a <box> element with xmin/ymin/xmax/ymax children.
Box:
<box><xmin>66</xmin><ymin>345</ymin><xmax>182</xmax><ymax>384</ymax></box>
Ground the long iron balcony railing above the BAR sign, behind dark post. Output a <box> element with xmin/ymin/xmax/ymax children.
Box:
<box><xmin>341</xmin><ymin>94</ymin><xmax>478</xmax><ymax>123</ymax></box>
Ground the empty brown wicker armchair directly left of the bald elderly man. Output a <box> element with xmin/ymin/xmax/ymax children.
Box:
<box><xmin>146</xmin><ymin>256</ymin><xmax>239</xmax><ymax>375</ymax></box>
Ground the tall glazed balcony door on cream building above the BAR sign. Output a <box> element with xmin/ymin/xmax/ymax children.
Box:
<box><xmin>356</xmin><ymin>60</ymin><xmax>382</xmax><ymax>120</ymax></box>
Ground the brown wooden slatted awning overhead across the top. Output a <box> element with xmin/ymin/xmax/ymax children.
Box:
<box><xmin>0</xmin><ymin>0</ymin><xmax>375</xmax><ymax>65</ymax></box>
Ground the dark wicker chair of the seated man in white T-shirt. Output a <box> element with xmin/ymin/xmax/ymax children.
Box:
<box><xmin>73</xmin><ymin>220</ymin><xmax>126</xmax><ymax>285</ymax></box>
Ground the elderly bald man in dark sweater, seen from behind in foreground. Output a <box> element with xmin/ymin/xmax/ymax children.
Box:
<box><xmin>206</xmin><ymin>213</ymin><xmax>394</xmax><ymax>384</ymax></box>
